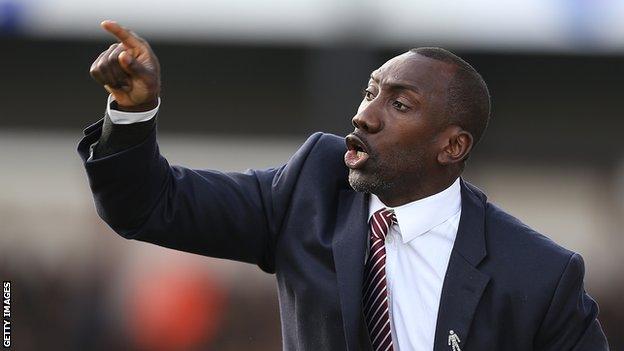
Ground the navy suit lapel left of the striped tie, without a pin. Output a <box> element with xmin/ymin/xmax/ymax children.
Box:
<box><xmin>332</xmin><ymin>189</ymin><xmax>368</xmax><ymax>350</ymax></box>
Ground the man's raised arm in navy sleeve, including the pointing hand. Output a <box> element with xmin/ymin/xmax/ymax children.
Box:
<box><xmin>78</xmin><ymin>22</ymin><xmax>318</xmax><ymax>272</ymax></box>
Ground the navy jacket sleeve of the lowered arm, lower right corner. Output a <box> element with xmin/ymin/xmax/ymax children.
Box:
<box><xmin>535</xmin><ymin>253</ymin><xmax>609</xmax><ymax>351</ymax></box>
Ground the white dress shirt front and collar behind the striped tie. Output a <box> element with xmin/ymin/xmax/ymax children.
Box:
<box><xmin>369</xmin><ymin>178</ymin><xmax>461</xmax><ymax>351</ymax></box>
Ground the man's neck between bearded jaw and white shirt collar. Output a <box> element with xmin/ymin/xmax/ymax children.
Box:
<box><xmin>375</xmin><ymin>176</ymin><xmax>458</xmax><ymax>207</ymax></box>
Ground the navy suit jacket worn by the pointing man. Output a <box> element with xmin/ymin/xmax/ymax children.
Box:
<box><xmin>78</xmin><ymin>120</ymin><xmax>608</xmax><ymax>351</ymax></box>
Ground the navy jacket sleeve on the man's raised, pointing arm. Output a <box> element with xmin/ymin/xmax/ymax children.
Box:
<box><xmin>78</xmin><ymin>114</ymin><xmax>321</xmax><ymax>273</ymax></box>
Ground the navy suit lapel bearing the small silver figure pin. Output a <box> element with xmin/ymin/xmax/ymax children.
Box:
<box><xmin>434</xmin><ymin>180</ymin><xmax>490</xmax><ymax>351</ymax></box>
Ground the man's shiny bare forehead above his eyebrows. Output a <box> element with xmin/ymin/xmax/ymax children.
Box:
<box><xmin>371</xmin><ymin>52</ymin><xmax>455</xmax><ymax>93</ymax></box>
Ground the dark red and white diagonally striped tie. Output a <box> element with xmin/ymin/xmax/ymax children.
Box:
<box><xmin>362</xmin><ymin>208</ymin><xmax>397</xmax><ymax>351</ymax></box>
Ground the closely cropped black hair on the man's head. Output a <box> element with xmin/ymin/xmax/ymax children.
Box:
<box><xmin>410</xmin><ymin>47</ymin><xmax>491</xmax><ymax>145</ymax></box>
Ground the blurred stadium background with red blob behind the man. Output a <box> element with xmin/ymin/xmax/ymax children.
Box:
<box><xmin>0</xmin><ymin>0</ymin><xmax>624</xmax><ymax>351</ymax></box>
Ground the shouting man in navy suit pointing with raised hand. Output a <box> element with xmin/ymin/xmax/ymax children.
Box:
<box><xmin>78</xmin><ymin>21</ymin><xmax>608</xmax><ymax>351</ymax></box>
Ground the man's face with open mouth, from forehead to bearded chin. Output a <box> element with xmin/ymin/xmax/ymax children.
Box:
<box><xmin>345</xmin><ymin>52</ymin><xmax>454</xmax><ymax>195</ymax></box>
